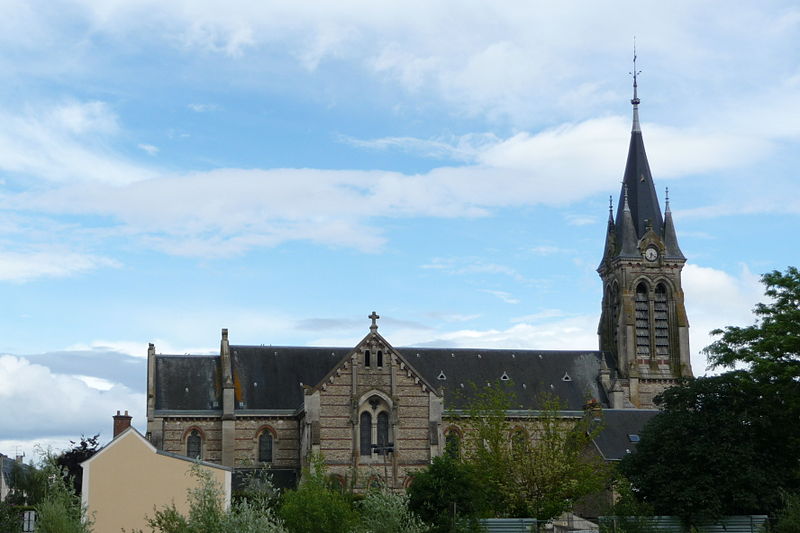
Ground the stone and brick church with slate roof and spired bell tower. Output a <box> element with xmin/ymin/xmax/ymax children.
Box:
<box><xmin>147</xmin><ymin>76</ymin><xmax>692</xmax><ymax>488</ymax></box>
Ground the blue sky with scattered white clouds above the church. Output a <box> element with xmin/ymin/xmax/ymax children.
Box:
<box><xmin>0</xmin><ymin>0</ymin><xmax>800</xmax><ymax>458</ymax></box>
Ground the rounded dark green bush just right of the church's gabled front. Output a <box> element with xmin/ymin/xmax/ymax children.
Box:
<box><xmin>408</xmin><ymin>454</ymin><xmax>488</xmax><ymax>533</ymax></box>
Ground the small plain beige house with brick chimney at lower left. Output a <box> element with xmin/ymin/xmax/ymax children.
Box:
<box><xmin>81</xmin><ymin>427</ymin><xmax>231</xmax><ymax>533</ymax></box>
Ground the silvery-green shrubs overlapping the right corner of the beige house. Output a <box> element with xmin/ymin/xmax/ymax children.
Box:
<box><xmin>142</xmin><ymin>465</ymin><xmax>286</xmax><ymax>533</ymax></box>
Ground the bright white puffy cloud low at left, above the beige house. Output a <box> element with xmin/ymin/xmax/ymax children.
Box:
<box><xmin>0</xmin><ymin>355</ymin><xmax>145</xmax><ymax>440</ymax></box>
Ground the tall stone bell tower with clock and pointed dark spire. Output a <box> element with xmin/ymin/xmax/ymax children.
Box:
<box><xmin>597</xmin><ymin>55</ymin><xmax>692</xmax><ymax>394</ymax></box>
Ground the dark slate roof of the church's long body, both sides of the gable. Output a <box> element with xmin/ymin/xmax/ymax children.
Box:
<box><xmin>155</xmin><ymin>345</ymin><xmax>612</xmax><ymax>411</ymax></box>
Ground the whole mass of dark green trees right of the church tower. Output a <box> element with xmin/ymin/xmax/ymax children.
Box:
<box><xmin>621</xmin><ymin>267</ymin><xmax>800</xmax><ymax>522</ymax></box>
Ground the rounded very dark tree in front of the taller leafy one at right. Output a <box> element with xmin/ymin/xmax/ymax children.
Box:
<box><xmin>620</xmin><ymin>371</ymin><xmax>798</xmax><ymax>523</ymax></box>
